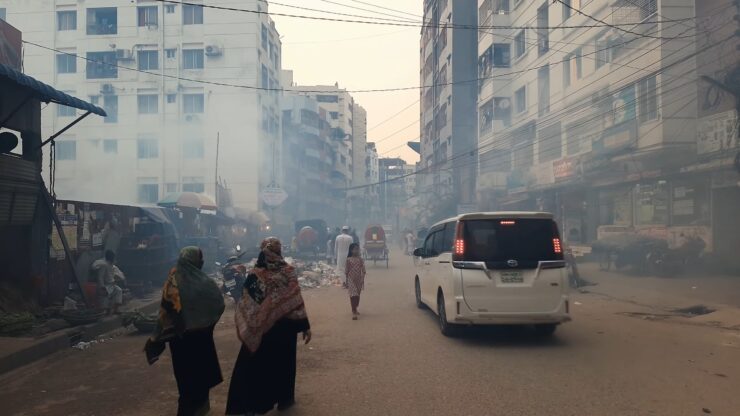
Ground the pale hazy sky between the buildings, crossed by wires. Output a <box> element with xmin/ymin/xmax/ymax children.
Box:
<box><xmin>269</xmin><ymin>0</ymin><xmax>423</xmax><ymax>163</ymax></box>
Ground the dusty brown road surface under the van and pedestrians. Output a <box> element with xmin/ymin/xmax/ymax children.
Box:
<box><xmin>0</xmin><ymin>255</ymin><xmax>740</xmax><ymax>416</ymax></box>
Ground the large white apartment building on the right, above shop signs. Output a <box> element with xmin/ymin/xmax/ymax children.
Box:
<box><xmin>478</xmin><ymin>0</ymin><xmax>699</xmax><ymax>243</ymax></box>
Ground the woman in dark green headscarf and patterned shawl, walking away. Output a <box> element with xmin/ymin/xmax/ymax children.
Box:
<box><xmin>145</xmin><ymin>247</ymin><xmax>224</xmax><ymax>416</ymax></box>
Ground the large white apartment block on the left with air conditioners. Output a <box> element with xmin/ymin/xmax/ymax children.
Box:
<box><xmin>0</xmin><ymin>0</ymin><xmax>281</xmax><ymax>210</ymax></box>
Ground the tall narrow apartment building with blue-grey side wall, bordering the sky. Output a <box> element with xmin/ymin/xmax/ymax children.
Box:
<box><xmin>419</xmin><ymin>0</ymin><xmax>477</xmax><ymax>222</ymax></box>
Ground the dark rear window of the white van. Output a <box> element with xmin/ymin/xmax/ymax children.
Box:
<box><xmin>462</xmin><ymin>218</ymin><xmax>563</xmax><ymax>263</ymax></box>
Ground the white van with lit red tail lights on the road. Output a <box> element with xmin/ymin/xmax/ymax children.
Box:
<box><xmin>414</xmin><ymin>212</ymin><xmax>570</xmax><ymax>336</ymax></box>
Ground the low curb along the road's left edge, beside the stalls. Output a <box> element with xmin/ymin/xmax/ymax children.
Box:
<box><xmin>0</xmin><ymin>298</ymin><xmax>160</xmax><ymax>375</ymax></box>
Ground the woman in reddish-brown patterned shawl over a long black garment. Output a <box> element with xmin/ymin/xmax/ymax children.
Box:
<box><xmin>226</xmin><ymin>237</ymin><xmax>311</xmax><ymax>415</ymax></box>
